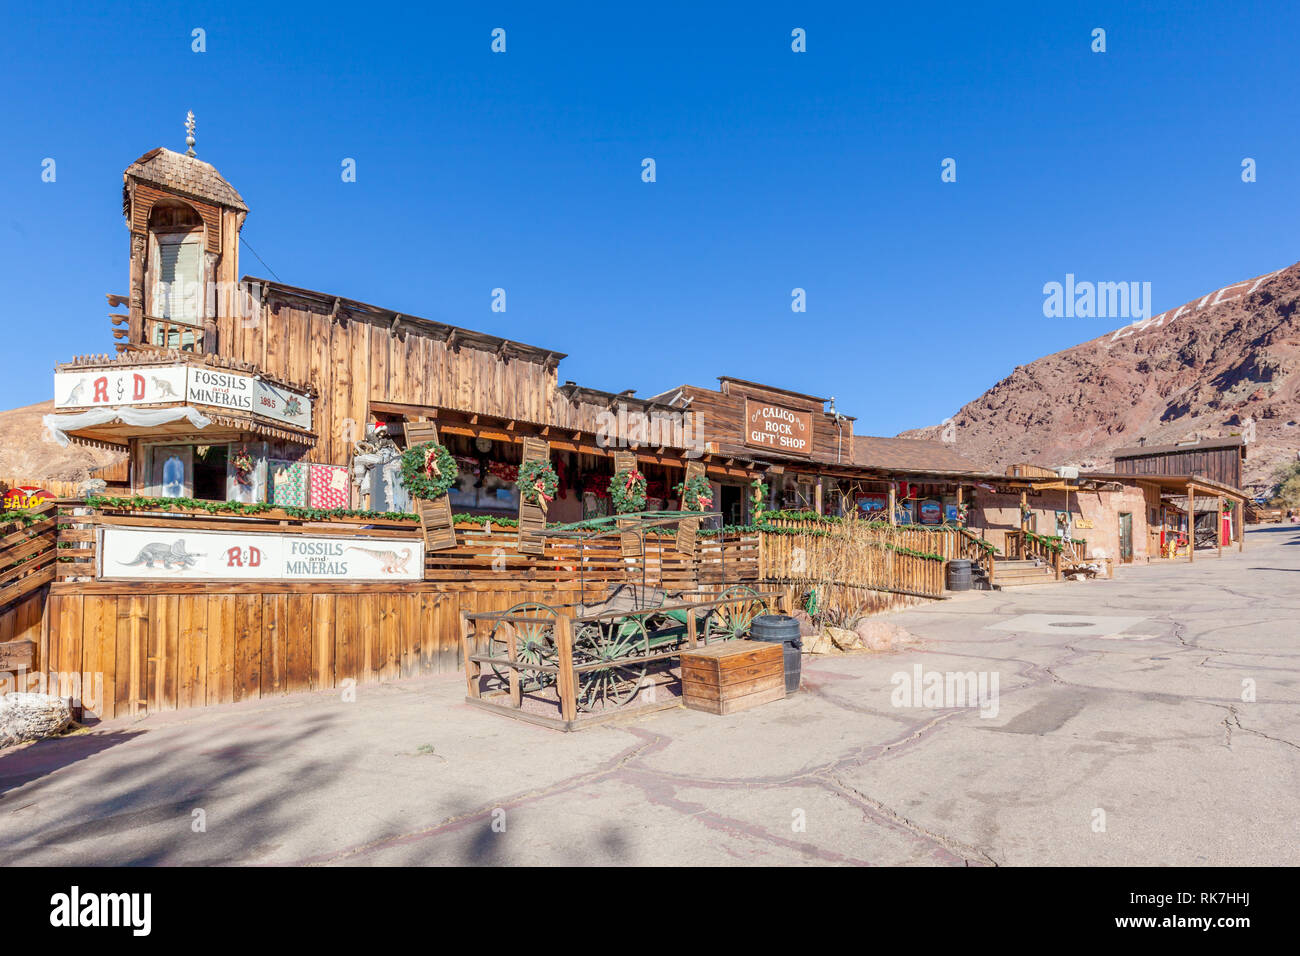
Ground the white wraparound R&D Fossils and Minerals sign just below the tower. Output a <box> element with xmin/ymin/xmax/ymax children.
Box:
<box><xmin>55</xmin><ymin>365</ymin><xmax>312</xmax><ymax>429</ymax></box>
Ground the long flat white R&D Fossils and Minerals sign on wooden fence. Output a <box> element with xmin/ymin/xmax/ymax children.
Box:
<box><xmin>99</xmin><ymin>527</ymin><xmax>424</xmax><ymax>581</ymax></box>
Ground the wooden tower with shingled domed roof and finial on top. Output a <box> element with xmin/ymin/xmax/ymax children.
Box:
<box><xmin>119</xmin><ymin>112</ymin><xmax>248</xmax><ymax>352</ymax></box>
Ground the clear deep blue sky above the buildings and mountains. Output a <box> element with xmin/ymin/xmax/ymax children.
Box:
<box><xmin>0</xmin><ymin>0</ymin><xmax>1300</xmax><ymax>434</ymax></box>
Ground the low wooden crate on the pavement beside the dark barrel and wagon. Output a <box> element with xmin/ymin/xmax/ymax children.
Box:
<box><xmin>681</xmin><ymin>641</ymin><xmax>785</xmax><ymax>714</ymax></box>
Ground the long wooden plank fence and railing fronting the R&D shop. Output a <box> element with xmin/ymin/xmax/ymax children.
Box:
<box><xmin>10</xmin><ymin>501</ymin><xmax>956</xmax><ymax>718</ymax></box>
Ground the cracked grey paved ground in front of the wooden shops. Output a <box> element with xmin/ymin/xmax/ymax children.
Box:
<box><xmin>0</xmin><ymin>528</ymin><xmax>1300</xmax><ymax>865</ymax></box>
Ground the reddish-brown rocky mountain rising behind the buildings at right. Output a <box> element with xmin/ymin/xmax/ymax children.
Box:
<box><xmin>900</xmin><ymin>263</ymin><xmax>1300</xmax><ymax>490</ymax></box>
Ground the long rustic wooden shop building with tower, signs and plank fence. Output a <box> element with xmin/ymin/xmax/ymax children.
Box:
<box><xmin>15</xmin><ymin>136</ymin><xmax>1248</xmax><ymax>717</ymax></box>
